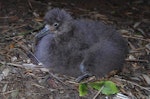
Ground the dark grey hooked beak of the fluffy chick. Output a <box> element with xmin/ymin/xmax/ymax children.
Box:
<box><xmin>35</xmin><ymin>25</ymin><xmax>50</xmax><ymax>39</ymax></box>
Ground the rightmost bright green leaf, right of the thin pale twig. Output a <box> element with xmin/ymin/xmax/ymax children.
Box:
<box><xmin>102</xmin><ymin>81</ymin><xmax>119</xmax><ymax>95</ymax></box>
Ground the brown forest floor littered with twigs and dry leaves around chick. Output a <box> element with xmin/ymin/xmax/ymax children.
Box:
<box><xmin>0</xmin><ymin>0</ymin><xmax>150</xmax><ymax>99</ymax></box>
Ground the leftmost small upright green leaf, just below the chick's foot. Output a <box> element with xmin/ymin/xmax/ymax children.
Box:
<box><xmin>79</xmin><ymin>83</ymin><xmax>88</xmax><ymax>96</ymax></box>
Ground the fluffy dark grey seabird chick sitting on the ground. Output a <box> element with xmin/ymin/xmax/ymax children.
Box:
<box><xmin>35</xmin><ymin>8</ymin><xmax>128</xmax><ymax>80</ymax></box>
